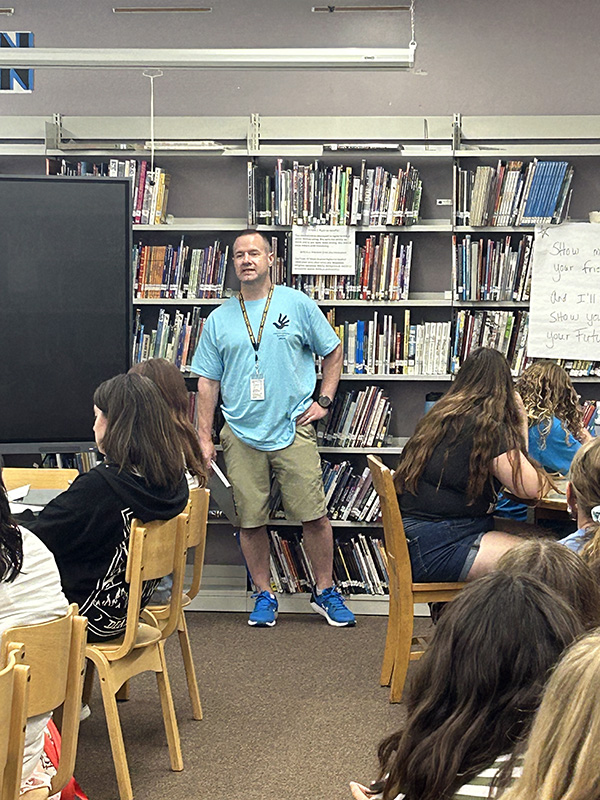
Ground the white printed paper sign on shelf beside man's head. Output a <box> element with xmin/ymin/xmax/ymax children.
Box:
<box><xmin>292</xmin><ymin>225</ymin><xmax>356</xmax><ymax>275</ymax></box>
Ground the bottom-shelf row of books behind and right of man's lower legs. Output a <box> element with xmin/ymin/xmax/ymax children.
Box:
<box><xmin>269</xmin><ymin>530</ymin><xmax>389</xmax><ymax>595</ymax></box>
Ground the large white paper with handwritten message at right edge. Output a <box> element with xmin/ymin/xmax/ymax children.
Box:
<box><xmin>527</xmin><ymin>222</ymin><xmax>600</xmax><ymax>361</ymax></box>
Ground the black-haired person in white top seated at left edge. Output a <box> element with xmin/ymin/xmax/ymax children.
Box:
<box><xmin>0</xmin><ymin>468</ymin><xmax>69</xmax><ymax>793</ymax></box>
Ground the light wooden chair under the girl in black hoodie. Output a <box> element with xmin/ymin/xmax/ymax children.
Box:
<box><xmin>86</xmin><ymin>514</ymin><xmax>187</xmax><ymax>800</ymax></box>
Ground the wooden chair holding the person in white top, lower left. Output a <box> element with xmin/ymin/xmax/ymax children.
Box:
<box><xmin>1</xmin><ymin>604</ymin><xmax>87</xmax><ymax>798</ymax></box>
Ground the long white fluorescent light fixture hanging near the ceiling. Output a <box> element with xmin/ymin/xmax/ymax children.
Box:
<box><xmin>0</xmin><ymin>43</ymin><xmax>416</xmax><ymax>70</ymax></box>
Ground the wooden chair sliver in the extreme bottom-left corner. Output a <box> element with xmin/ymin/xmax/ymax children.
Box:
<box><xmin>0</xmin><ymin>646</ymin><xmax>29</xmax><ymax>800</ymax></box>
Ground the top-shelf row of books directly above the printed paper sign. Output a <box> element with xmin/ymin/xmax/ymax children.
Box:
<box><xmin>248</xmin><ymin>158</ymin><xmax>422</xmax><ymax>226</ymax></box>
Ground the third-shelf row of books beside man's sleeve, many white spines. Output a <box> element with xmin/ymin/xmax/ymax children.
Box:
<box><xmin>326</xmin><ymin>308</ymin><xmax>451</xmax><ymax>375</ymax></box>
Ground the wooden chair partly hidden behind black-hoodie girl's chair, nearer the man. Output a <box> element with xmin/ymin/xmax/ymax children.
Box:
<box><xmin>148</xmin><ymin>488</ymin><xmax>210</xmax><ymax>719</ymax></box>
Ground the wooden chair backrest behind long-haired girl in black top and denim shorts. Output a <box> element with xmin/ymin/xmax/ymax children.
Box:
<box><xmin>367</xmin><ymin>456</ymin><xmax>412</xmax><ymax>586</ymax></box>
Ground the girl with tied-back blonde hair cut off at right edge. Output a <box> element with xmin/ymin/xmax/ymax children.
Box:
<box><xmin>560</xmin><ymin>439</ymin><xmax>600</xmax><ymax>574</ymax></box>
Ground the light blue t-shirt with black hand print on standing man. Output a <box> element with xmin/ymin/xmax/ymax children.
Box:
<box><xmin>192</xmin><ymin>286</ymin><xmax>340</xmax><ymax>450</ymax></box>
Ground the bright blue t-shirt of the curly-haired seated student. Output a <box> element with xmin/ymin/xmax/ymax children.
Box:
<box><xmin>496</xmin><ymin>417</ymin><xmax>581</xmax><ymax>520</ymax></box>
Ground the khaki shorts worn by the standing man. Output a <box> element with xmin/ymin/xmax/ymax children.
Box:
<box><xmin>221</xmin><ymin>423</ymin><xmax>327</xmax><ymax>528</ymax></box>
